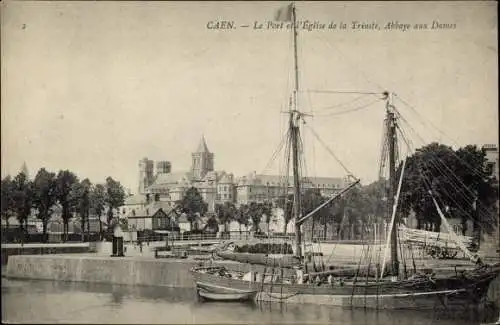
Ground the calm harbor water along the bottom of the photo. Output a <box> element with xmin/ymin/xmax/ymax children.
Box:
<box><xmin>2</xmin><ymin>278</ymin><xmax>496</xmax><ymax>325</ymax></box>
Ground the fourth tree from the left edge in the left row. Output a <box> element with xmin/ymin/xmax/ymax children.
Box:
<box><xmin>56</xmin><ymin>170</ymin><xmax>79</xmax><ymax>241</ymax></box>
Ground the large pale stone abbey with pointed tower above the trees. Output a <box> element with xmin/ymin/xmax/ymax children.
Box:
<box><xmin>139</xmin><ymin>137</ymin><xmax>345</xmax><ymax>212</ymax></box>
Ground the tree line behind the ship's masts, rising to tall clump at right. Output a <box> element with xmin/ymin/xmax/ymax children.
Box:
<box><xmin>199</xmin><ymin>143</ymin><xmax>498</xmax><ymax>237</ymax></box>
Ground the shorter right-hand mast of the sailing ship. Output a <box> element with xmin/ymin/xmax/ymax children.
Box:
<box><xmin>385</xmin><ymin>93</ymin><xmax>399</xmax><ymax>276</ymax></box>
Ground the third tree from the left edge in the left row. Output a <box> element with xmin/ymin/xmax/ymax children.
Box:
<box><xmin>33</xmin><ymin>168</ymin><xmax>57</xmax><ymax>242</ymax></box>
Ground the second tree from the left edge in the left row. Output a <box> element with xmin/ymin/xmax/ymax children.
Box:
<box><xmin>12</xmin><ymin>172</ymin><xmax>33</xmax><ymax>238</ymax></box>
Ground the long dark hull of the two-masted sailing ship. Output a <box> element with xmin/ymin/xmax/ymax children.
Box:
<box><xmin>192</xmin><ymin>270</ymin><xmax>498</xmax><ymax>310</ymax></box>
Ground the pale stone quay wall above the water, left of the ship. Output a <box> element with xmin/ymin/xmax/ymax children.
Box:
<box><xmin>4</xmin><ymin>255</ymin><xmax>274</xmax><ymax>288</ymax></box>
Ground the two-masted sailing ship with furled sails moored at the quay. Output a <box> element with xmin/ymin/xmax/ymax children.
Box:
<box><xmin>191</xmin><ymin>4</ymin><xmax>500</xmax><ymax>310</ymax></box>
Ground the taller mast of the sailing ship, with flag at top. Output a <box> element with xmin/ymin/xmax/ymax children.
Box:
<box><xmin>290</xmin><ymin>3</ymin><xmax>302</xmax><ymax>259</ymax></box>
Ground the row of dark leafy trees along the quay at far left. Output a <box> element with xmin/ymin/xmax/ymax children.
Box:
<box><xmin>1</xmin><ymin>168</ymin><xmax>125</xmax><ymax>241</ymax></box>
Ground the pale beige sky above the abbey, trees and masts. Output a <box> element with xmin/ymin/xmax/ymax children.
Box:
<box><xmin>1</xmin><ymin>1</ymin><xmax>498</xmax><ymax>192</ymax></box>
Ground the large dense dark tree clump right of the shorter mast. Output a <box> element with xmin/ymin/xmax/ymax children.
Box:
<box><xmin>397</xmin><ymin>143</ymin><xmax>498</xmax><ymax>237</ymax></box>
